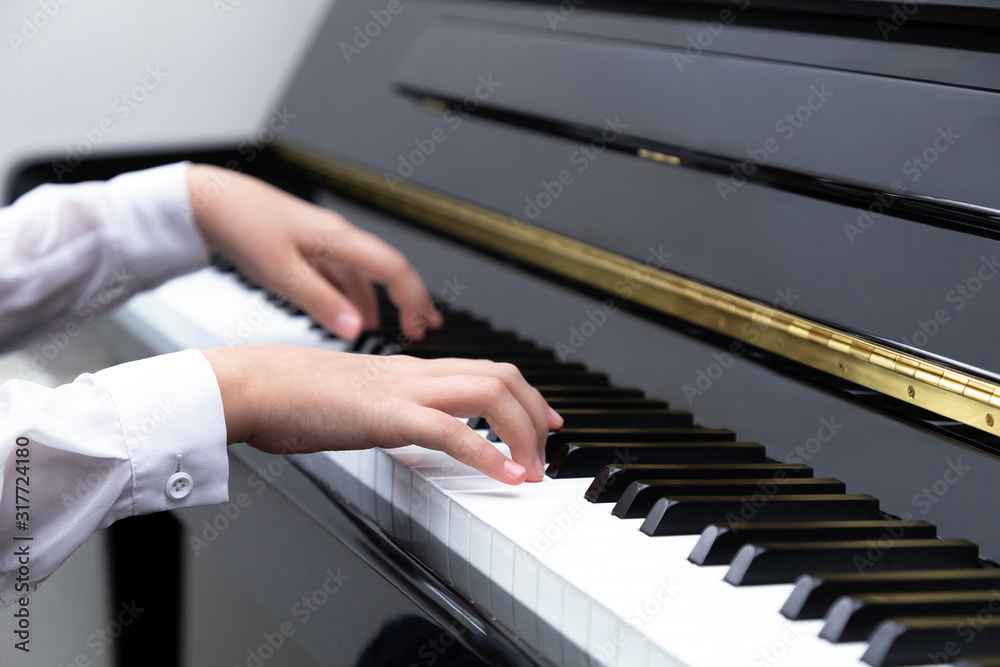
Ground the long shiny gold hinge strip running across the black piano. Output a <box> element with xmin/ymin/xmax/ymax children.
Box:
<box><xmin>272</xmin><ymin>142</ymin><xmax>1000</xmax><ymax>433</ymax></box>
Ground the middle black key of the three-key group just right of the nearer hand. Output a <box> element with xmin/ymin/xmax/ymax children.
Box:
<box><xmin>611</xmin><ymin>477</ymin><xmax>846</xmax><ymax>519</ymax></box>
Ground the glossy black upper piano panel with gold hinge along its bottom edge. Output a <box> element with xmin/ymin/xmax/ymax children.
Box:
<box><xmin>266</xmin><ymin>0</ymin><xmax>1000</xmax><ymax>444</ymax></box>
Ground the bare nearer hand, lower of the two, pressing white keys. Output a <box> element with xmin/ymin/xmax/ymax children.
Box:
<box><xmin>204</xmin><ymin>345</ymin><xmax>562</xmax><ymax>484</ymax></box>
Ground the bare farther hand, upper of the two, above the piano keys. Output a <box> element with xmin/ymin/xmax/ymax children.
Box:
<box><xmin>188</xmin><ymin>165</ymin><xmax>443</xmax><ymax>340</ymax></box>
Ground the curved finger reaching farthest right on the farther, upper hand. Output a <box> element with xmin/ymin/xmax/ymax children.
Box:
<box><xmin>336</xmin><ymin>230</ymin><xmax>444</xmax><ymax>340</ymax></box>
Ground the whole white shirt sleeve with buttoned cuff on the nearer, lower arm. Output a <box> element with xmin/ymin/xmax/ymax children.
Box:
<box><xmin>0</xmin><ymin>350</ymin><xmax>229</xmax><ymax>607</ymax></box>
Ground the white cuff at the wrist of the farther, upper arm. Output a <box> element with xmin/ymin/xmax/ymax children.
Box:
<box><xmin>108</xmin><ymin>162</ymin><xmax>209</xmax><ymax>292</ymax></box>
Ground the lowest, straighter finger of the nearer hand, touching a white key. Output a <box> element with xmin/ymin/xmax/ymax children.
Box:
<box><xmin>401</xmin><ymin>408</ymin><xmax>527</xmax><ymax>485</ymax></box>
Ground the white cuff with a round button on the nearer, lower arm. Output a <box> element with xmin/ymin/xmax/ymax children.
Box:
<box><xmin>95</xmin><ymin>350</ymin><xmax>229</xmax><ymax>520</ymax></box>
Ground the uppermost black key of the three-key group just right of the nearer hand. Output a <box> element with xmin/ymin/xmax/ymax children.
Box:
<box><xmin>584</xmin><ymin>463</ymin><xmax>813</xmax><ymax>504</ymax></box>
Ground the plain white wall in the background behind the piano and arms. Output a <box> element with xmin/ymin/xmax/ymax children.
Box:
<box><xmin>0</xmin><ymin>0</ymin><xmax>330</xmax><ymax>667</ymax></box>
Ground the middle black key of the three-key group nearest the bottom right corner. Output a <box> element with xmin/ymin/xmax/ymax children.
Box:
<box><xmin>819</xmin><ymin>590</ymin><xmax>1000</xmax><ymax>644</ymax></box>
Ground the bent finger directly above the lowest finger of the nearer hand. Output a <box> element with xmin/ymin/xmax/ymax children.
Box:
<box><xmin>420</xmin><ymin>375</ymin><xmax>548</xmax><ymax>482</ymax></box>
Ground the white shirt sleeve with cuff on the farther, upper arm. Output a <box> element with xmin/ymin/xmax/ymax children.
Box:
<box><xmin>0</xmin><ymin>162</ymin><xmax>209</xmax><ymax>349</ymax></box>
